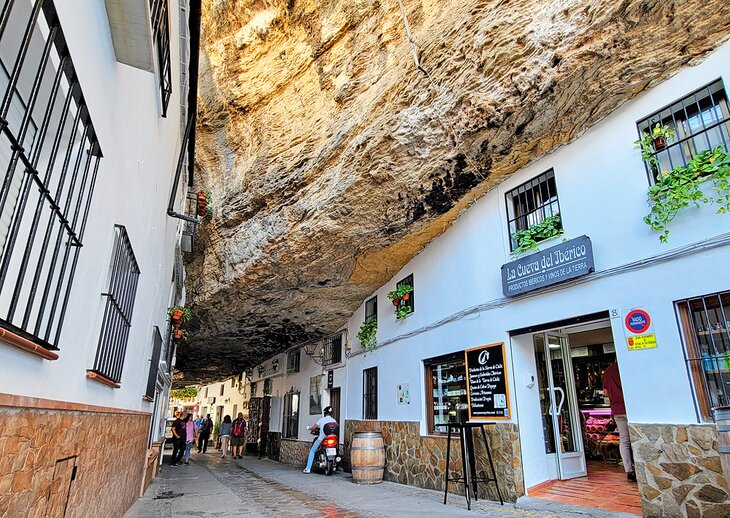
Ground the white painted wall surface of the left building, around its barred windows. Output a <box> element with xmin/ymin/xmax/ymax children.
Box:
<box><xmin>0</xmin><ymin>0</ymin><xmax>188</xmax><ymax>412</ymax></box>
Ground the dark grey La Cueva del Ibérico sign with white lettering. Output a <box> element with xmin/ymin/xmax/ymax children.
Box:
<box><xmin>502</xmin><ymin>236</ymin><xmax>595</xmax><ymax>297</ymax></box>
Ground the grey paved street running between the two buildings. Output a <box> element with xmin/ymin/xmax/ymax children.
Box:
<box><xmin>126</xmin><ymin>453</ymin><xmax>632</xmax><ymax>518</ymax></box>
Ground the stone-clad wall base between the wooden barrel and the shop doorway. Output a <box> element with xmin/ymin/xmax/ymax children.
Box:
<box><xmin>344</xmin><ymin>421</ymin><xmax>525</xmax><ymax>502</ymax></box>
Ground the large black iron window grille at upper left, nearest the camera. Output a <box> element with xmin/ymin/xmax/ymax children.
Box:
<box><xmin>0</xmin><ymin>0</ymin><xmax>102</xmax><ymax>349</ymax></box>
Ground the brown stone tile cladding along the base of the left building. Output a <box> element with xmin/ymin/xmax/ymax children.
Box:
<box><xmin>0</xmin><ymin>407</ymin><xmax>150</xmax><ymax>517</ymax></box>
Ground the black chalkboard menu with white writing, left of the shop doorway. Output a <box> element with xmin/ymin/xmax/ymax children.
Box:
<box><xmin>464</xmin><ymin>343</ymin><xmax>510</xmax><ymax>421</ymax></box>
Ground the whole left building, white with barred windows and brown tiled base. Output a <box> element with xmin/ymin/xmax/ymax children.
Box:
<box><xmin>0</xmin><ymin>0</ymin><xmax>199</xmax><ymax>516</ymax></box>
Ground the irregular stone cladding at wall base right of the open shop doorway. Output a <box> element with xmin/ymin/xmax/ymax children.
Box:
<box><xmin>630</xmin><ymin>423</ymin><xmax>730</xmax><ymax>518</ymax></box>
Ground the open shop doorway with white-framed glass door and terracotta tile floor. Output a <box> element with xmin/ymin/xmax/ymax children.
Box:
<box><xmin>528</xmin><ymin>319</ymin><xmax>641</xmax><ymax>514</ymax></box>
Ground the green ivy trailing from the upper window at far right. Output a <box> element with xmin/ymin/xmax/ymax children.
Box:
<box><xmin>642</xmin><ymin>146</ymin><xmax>730</xmax><ymax>243</ymax></box>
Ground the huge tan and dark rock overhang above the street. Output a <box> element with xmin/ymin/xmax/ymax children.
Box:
<box><xmin>178</xmin><ymin>0</ymin><xmax>730</xmax><ymax>380</ymax></box>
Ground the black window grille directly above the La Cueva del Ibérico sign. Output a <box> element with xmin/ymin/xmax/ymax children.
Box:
<box><xmin>505</xmin><ymin>169</ymin><xmax>563</xmax><ymax>251</ymax></box>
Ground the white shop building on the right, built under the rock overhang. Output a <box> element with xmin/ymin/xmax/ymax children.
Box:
<box><xmin>252</xmin><ymin>38</ymin><xmax>730</xmax><ymax>516</ymax></box>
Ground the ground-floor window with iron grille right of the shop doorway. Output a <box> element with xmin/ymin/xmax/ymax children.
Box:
<box><xmin>677</xmin><ymin>291</ymin><xmax>730</xmax><ymax>419</ymax></box>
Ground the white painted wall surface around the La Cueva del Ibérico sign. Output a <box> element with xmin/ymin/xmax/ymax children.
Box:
<box><xmin>345</xmin><ymin>39</ymin><xmax>730</xmax><ymax>442</ymax></box>
